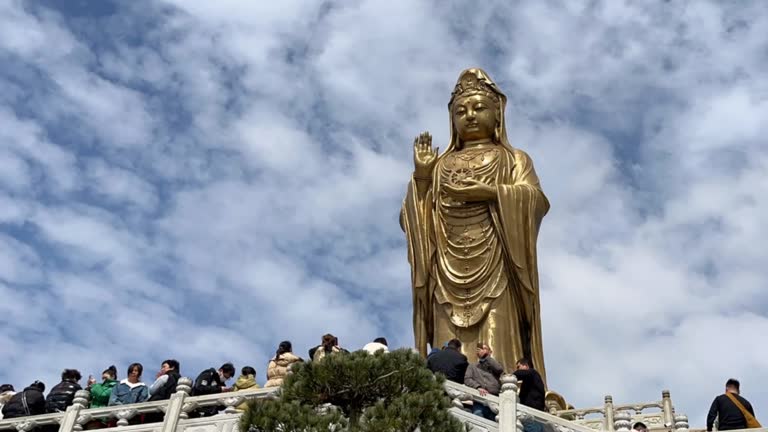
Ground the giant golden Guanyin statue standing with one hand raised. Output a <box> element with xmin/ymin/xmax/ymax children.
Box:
<box><xmin>400</xmin><ymin>69</ymin><xmax>549</xmax><ymax>382</ymax></box>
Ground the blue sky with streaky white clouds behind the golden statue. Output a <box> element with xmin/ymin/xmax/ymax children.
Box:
<box><xmin>0</xmin><ymin>0</ymin><xmax>768</xmax><ymax>426</ymax></box>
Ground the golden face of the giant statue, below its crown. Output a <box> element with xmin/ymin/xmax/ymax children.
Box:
<box><xmin>451</xmin><ymin>94</ymin><xmax>498</xmax><ymax>141</ymax></box>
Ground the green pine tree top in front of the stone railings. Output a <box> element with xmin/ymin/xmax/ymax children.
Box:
<box><xmin>240</xmin><ymin>349</ymin><xmax>465</xmax><ymax>432</ymax></box>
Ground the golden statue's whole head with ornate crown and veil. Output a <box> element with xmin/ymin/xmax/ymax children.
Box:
<box><xmin>448</xmin><ymin>69</ymin><xmax>506</xmax><ymax>146</ymax></box>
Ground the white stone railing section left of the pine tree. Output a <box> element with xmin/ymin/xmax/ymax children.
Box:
<box><xmin>0</xmin><ymin>377</ymin><xmax>279</xmax><ymax>432</ymax></box>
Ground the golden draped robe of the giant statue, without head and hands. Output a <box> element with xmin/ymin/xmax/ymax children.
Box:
<box><xmin>400</xmin><ymin>145</ymin><xmax>549</xmax><ymax>383</ymax></box>
